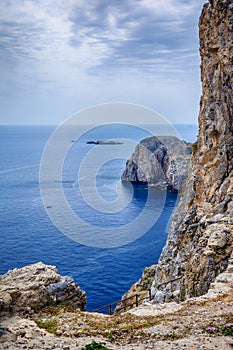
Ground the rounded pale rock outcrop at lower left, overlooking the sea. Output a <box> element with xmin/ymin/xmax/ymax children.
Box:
<box><xmin>0</xmin><ymin>262</ymin><xmax>86</xmax><ymax>317</ymax></box>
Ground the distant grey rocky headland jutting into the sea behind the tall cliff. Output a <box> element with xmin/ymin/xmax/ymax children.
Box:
<box><xmin>121</xmin><ymin>136</ymin><xmax>191</xmax><ymax>191</ymax></box>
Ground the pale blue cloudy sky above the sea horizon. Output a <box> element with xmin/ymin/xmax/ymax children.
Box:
<box><xmin>0</xmin><ymin>0</ymin><xmax>206</xmax><ymax>124</ymax></box>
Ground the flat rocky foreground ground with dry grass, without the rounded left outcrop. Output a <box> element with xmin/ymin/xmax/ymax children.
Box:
<box><xmin>0</xmin><ymin>259</ymin><xmax>233</xmax><ymax>350</ymax></box>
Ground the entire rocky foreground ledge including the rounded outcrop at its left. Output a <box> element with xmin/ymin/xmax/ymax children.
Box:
<box><xmin>0</xmin><ymin>259</ymin><xmax>233</xmax><ymax>350</ymax></box>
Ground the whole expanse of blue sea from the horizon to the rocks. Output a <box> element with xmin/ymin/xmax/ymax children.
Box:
<box><xmin>0</xmin><ymin>124</ymin><xmax>198</xmax><ymax>311</ymax></box>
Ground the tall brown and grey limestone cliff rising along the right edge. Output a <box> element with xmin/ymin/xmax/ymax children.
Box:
<box><xmin>152</xmin><ymin>0</ymin><xmax>233</xmax><ymax>302</ymax></box>
